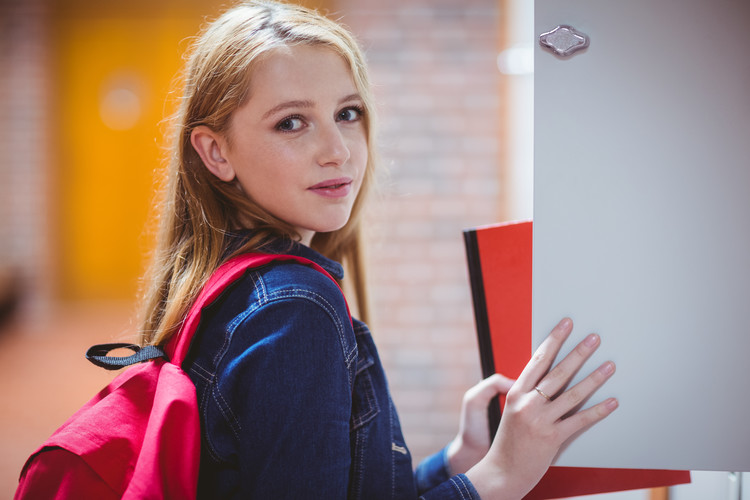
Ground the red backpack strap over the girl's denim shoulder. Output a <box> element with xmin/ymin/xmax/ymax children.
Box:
<box><xmin>165</xmin><ymin>253</ymin><xmax>351</xmax><ymax>365</ymax></box>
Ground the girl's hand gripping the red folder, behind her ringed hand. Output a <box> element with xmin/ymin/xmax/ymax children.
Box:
<box><xmin>447</xmin><ymin>374</ymin><xmax>514</xmax><ymax>474</ymax></box>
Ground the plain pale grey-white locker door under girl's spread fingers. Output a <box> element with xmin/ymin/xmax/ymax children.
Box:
<box><xmin>533</xmin><ymin>0</ymin><xmax>750</xmax><ymax>471</ymax></box>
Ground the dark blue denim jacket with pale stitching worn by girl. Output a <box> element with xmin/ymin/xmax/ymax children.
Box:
<box><xmin>183</xmin><ymin>238</ymin><xmax>479</xmax><ymax>500</ymax></box>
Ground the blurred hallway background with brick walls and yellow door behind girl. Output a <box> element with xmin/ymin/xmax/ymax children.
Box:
<box><xmin>0</xmin><ymin>0</ymin><xmax>704</xmax><ymax>498</ymax></box>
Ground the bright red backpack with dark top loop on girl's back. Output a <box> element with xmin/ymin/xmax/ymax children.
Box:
<box><xmin>15</xmin><ymin>254</ymin><xmax>344</xmax><ymax>500</ymax></box>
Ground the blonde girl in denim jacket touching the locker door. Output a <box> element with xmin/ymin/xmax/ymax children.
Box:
<box><xmin>142</xmin><ymin>0</ymin><xmax>617</xmax><ymax>499</ymax></box>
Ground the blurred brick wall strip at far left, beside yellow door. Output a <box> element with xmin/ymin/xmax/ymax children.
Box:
<box><xmin>0</xmin><ymin>0</ymin><xmax>51</xmax><ymax>317</ymax></box>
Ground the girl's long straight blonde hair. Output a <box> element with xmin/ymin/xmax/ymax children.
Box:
<box><xmin>140</xmin><ymin>0</ymin><xmax>375</xmax><ymax>345</ymax></box>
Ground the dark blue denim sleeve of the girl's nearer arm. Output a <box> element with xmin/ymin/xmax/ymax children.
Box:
<box><xmin>213</xmin><ymin>290</ymin><xmax>356</xmax><ymax>499</ymax></box>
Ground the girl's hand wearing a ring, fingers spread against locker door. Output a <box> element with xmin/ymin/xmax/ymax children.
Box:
<box><xmin>467</xmin><ymin>318</ymin><xmax>618</xmax><ymax>499</ymax></box>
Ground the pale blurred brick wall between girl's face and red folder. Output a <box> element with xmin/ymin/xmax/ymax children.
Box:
<box><xmin>337</xmin><ymin>0</ymin><xmax>501</xmax><ymax>462</ymax></box>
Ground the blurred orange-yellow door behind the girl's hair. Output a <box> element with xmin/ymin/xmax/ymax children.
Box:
<box><xmin>52</xmin><ymin>0</ymin><xmax>328</xmax><ymax>299</ymax></box>
